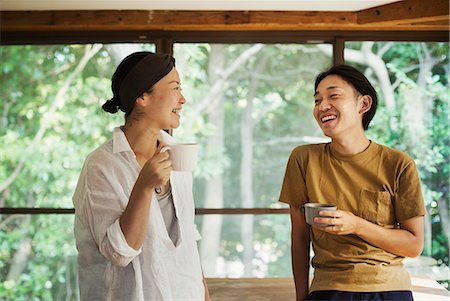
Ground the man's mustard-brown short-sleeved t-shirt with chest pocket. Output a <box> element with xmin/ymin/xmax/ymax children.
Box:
<box><xmin>280</xmin><ymin>142</ymin><xmax>426</xmax><ymax>292</ymax></box>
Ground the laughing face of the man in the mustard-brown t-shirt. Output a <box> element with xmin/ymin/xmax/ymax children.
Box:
<box><xmin>313</xmin><ymin>75</ymin><xmax>371</xmax><ymax>139</ymax></box>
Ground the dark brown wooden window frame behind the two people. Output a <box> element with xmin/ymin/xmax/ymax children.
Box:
<box><xmin>0</xmin><ymin>30</ymin><xmax>449</xmax><ymax>215</ymax></box>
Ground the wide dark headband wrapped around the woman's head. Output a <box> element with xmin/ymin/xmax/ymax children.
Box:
<box><xmin>119</xmin><ymin>53</ymin><xmax>175</xmax><ymax>113</ymax></box>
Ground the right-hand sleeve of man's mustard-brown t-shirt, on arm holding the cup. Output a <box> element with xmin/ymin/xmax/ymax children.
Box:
<box><xmin>395</xmin><ymin>159</ymin><xmax>426</xmax><ymax>222</ymax></box>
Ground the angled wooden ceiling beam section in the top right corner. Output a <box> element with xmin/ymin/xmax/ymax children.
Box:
<box><xmin>357</xmin><ymin>0</ymin><xmax>449</xmax><ymax>25</ymax></box>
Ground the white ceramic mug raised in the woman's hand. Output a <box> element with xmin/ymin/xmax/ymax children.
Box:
<box><xmin>161</xmin><ymin>143</ymin><xmax>199</xmax><ymax>171</ymax></box>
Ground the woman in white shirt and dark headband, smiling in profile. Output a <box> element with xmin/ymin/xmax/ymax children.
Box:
<box><xmin>73</xmin><ymin>52</ymin><xmax>209</xmax><ymax>301</ymax></box>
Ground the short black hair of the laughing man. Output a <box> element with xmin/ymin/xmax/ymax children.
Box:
<box><xmin>314</xmin><ymin>65</ymin><xmax>378</xmax><ymax>130</ymax></box>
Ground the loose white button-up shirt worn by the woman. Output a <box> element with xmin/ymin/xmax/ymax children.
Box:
<box><xmin>73</xmin><ymin>128</ymin><xmax>204</xmax><ymax>301</ymax></box>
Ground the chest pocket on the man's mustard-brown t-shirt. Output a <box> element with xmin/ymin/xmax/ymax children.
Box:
<box><xmin>358</xmin><ymin>189</ymin><xmax>395</xmax><ymax>226</ymax></box>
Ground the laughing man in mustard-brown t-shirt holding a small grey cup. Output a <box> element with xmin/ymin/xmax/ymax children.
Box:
<box><xmin>280</xmin><ymin>65</ymin><xmax>425</xmax><ymax>301</ymax></box>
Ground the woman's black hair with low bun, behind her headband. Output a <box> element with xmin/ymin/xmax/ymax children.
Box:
<box><xmin>102</xmin><ymin>51</ymin><xmax>151</xmax><ymax>114</ymax></box>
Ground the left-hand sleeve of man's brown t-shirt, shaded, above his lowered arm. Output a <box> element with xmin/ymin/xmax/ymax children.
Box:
<box><xmin>279</xmin><ymin>149</ymin><xmax>307</xmax><ymax>207</ymax></box>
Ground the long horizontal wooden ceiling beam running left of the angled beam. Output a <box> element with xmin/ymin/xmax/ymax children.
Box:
<box><xmin>1</xmin><ymin>10</ymin><xmax>356</xmax><ymax>30</ymax></box>
